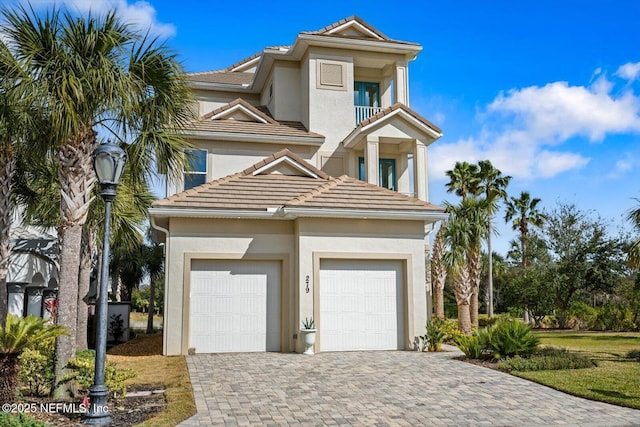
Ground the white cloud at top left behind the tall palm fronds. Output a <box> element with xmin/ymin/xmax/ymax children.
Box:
<box><xmin>24</xmin><ymin>0</ymin><xmax>176</xmax><ymax>38</ymax></box>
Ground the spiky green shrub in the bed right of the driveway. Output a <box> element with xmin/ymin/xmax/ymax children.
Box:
<box><xmin>485</xmin><ymin>320</ymin><xmax>540</xmax><ymax>359</ymax></box>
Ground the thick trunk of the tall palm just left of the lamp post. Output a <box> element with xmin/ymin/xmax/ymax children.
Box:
<box><xmin>54</xmin><ymin>138</ymin><xmax>96</xmax><ymax>398</ymax></box>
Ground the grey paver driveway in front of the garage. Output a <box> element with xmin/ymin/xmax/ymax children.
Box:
<box><xmin>181</xmin><ymin>351</ymin><xmax>640</xmax><ymax>426</ymax></box>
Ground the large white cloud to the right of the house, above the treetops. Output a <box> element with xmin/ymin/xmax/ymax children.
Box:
<box><xmin>429</xmin><ymin>73</ymin><xmax>640</xmax><ymax>180</ymax></box>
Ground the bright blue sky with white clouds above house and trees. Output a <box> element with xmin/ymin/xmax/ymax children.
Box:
<box><xmin>7</xmin><ymin>0</ymin><xmax>640</xmax><ymax>253</ymax></box>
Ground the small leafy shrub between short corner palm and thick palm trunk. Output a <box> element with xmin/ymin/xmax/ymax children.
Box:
<box><xmin>19</xmin><ymin>340</ymin><xmax>56</xmax><ymax>396</ymax></box>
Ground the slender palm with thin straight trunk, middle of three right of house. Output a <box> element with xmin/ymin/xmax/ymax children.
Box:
<box><xmin>478</xmin><ymin>160</ymin><xmax>511</xmax><ymax>317</ymax></box>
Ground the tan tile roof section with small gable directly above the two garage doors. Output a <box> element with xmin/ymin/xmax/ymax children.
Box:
<box><xmin>153</xmin><ymin>150</ymin><xmax>444</xmax><ymax>217</ymax></box>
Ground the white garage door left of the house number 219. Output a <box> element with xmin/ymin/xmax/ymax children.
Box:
<box><xmin>189</xmin><ymin>260</ymin><xmax>280</xmax><ymax>353</ymax></box>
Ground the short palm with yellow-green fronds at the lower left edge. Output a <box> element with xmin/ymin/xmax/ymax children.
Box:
<box><xmin>0</xmin><ymin>315</ymin><xmax>67</xmax><ymax>404</ymax></box>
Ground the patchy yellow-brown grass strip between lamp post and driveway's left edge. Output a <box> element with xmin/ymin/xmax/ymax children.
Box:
<box><xmin>107</xmin><ymin>333</ymin><xmax>196</xmax><ymax>427</ymax></box>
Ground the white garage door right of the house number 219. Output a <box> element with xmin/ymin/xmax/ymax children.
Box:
<box><xmin>319</xmin><ymin>260</ymin><xmax>404</xmax><ymax>351</ymax></box>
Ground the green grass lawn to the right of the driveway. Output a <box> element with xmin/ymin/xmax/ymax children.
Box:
<box><xmin>514</xmin><ymin>331</ymin><xmax>640</xmax><ymax>409</ymax></box>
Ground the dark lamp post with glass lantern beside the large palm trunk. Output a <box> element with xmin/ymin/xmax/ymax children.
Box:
<box><xmin>84</xmin><ymin>141</ymin><xmax>127</xmax><ymax>426</ymax></box>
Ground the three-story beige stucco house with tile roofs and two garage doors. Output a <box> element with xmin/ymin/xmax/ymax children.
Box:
<box><xmin>150</xmin><ymin>17</ymin><xmax>444</xmax><ymax>355</ymax></box>
